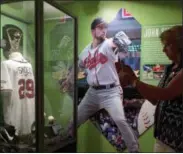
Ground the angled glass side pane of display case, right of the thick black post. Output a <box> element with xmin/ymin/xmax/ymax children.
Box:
<box><xmin>44</xmin><ymin>2</ymin><xmax>74</xmax><ymax>152</ymax></box>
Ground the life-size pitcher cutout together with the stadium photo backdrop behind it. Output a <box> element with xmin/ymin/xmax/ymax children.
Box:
<box><xmin>59</xmin><ymin>8</ymin><xmax>154</xmax><ymax>152</ymax></box>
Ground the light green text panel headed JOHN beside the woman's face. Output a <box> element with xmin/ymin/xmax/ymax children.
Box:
<box><xmin>140</xmin><ymin>24</ymin><xmax>179</xmax><ymax>85</ymax></box>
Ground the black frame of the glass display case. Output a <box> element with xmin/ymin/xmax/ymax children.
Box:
<box><xmin>0</xmin><ymin>0</ymin><xmax>78</xmax><ymax>152</ymax></box>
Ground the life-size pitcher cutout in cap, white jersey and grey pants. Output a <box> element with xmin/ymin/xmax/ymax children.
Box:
<box><xmin>68</xmin><ymin>18</ymin><xmax>139</xmax><ymax>152</ymax></box>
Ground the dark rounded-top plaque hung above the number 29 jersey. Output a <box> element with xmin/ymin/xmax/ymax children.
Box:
<box><xmin>3</xmin><ymin>24</ymin><xmax>23</xmax><ymax>59</ymax></box>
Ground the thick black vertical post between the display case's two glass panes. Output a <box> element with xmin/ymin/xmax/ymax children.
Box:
<box><xmin>35</xmin><ymin>0</ymin><xmax>44</xmax><ymax>153</ymax></box>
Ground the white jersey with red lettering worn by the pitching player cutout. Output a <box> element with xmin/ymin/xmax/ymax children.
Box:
<box><xmin>79</xmin><ymin>39</ymin><xmax>119</xmax><ymax>86</ymax></box>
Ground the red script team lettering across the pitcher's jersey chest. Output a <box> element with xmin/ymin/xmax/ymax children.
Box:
<box><xmin>84</xmin><ymin>49</ymin><xmax>108</xmax><ymax>70</ymax></box>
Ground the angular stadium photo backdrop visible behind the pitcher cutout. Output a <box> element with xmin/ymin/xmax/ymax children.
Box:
<box><xmin>86</xmin><ymin>8</ymin><xmax>154</xmax><ymax>152</ymax></box>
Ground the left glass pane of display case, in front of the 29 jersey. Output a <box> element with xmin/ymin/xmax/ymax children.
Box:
<box><xmin>0</xmin><ymin>1</ymin><xmax>36</xmax><ymax>152</ymax></box>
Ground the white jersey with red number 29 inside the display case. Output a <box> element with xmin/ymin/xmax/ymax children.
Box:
<box><xmin>1</xmin><ymin>52</ymin><xmax>35</xmax><ymax>135</ymax></box>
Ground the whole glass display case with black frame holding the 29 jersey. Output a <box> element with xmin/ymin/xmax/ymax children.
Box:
<box><xmin>0</xmin><ymin>0</ymin><xmax>77</xmax><ymax>152</ymax></box>
